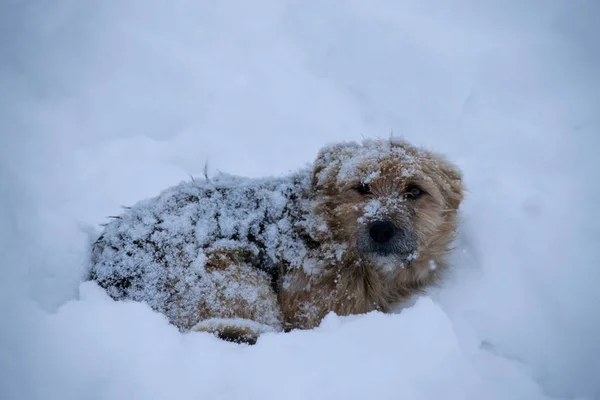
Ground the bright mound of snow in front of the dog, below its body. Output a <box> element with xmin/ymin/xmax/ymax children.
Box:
<box><xmin>28</xmin><ymin>283</ymin><xmax>547</xmax><ymax>400</ymax></box>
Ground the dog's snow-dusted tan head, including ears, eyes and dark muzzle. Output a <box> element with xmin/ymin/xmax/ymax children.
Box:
<box><xmin>313</xmin><ymin>141</ymin><xmax>462</xmax><ymax>269</ymax></box>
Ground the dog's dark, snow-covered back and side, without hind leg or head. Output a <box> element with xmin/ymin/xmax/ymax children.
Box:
<box><xmin>91</xmin><ymin>171</ymin><xmax>310</xmax><ymax>329</ymax></box>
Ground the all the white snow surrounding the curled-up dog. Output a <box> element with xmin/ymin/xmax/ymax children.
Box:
<box><xmin>0</xmin><ymin>0</ymin><xmax>600</xmax><ymax>399</ymax></box>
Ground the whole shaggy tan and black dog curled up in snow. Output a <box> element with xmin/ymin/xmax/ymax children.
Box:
<box><xmin>91</xmin><ymin>140</ymin><xmax>462</xmax><ymax>342</ymax></box>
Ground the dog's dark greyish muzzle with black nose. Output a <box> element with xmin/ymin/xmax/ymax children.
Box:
<box><xmin>358</xmin><ymin>220</ymin><xmax>418</xmax><ymax>260</ymax></box>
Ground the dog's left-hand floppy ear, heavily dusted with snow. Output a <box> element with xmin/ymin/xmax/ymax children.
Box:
<box><xmin>312</xmin><ymin>142</ymin><xmax>359</xmax><ymax>194</ymax></box>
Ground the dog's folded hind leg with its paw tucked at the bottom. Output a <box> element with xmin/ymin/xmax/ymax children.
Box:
<box><xmin>192</xmin><ymin>248</ymin><xmax>282</xmax><ymax>343</ymax></box>
